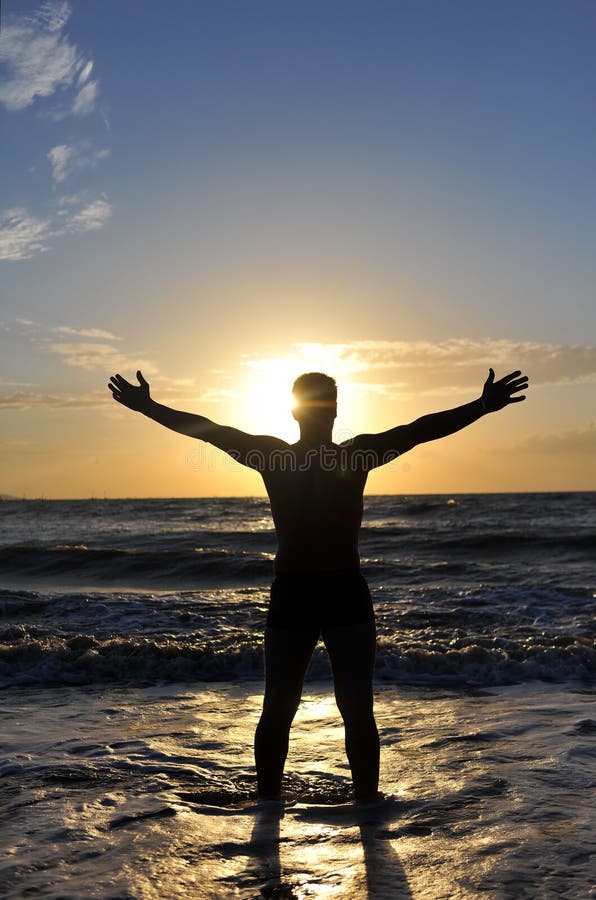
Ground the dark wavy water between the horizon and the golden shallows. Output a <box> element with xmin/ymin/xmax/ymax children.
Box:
<box><xmin>0</xmin><ymin>492</ymin><xmax>596</xmax><ymax>686</ymax></box>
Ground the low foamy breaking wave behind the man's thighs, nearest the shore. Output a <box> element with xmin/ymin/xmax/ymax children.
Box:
<box><xmin>0</xmin><ymin>633</ymin><xmax>596</xmax><ymax>687</ymax></box>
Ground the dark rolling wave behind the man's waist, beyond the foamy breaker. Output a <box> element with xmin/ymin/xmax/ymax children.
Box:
<box><xmin>0</xmin><ymin>526</ymin><xmax>596</xmax><ymax>586</ymax></box>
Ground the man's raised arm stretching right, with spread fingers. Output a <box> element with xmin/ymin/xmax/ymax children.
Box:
<box><xmin>346</xmin><ymin>369</ymin><xmax>528</xmax><ymax>468</ymax></box>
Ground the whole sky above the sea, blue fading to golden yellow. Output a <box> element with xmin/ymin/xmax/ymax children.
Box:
<box><xmin>0</xmin><ymin>0</ymin><xmax>596</xmax><ymax>494</ymax></box>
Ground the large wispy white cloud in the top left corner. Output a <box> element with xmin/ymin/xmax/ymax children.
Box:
<box><xmin>0</xmin><ymin>0</ymin><xmax>98</xmax><ymax>115</ymax></box>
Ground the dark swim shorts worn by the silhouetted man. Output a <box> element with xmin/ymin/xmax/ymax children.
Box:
<box><xmin>267</xmin><ymin>569</ymin><xmax>375</xmax><ymax>631</ymax></box>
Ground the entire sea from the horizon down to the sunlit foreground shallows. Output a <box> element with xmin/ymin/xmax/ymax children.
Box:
<box><xmin>0</xmin><ymin>492</ymin><xmax>596</xmax><ymax>898</ymax></box>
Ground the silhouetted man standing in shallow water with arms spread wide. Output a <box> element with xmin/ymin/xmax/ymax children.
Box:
<box><xmin>108</xmin><ymin>369</ymin><xmax>528</xmax><ymax>803</ymax></box>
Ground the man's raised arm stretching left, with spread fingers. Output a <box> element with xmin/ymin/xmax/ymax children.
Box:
<box><xmin>108</xmin><ymin>371</ymin><xmax>288</xmax><ymax>468</ymax></box>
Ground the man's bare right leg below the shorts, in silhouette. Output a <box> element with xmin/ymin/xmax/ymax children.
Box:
<box><xmin>323</xmin><ymin>622</ymin><xmax>379</xmax><ymax>802</ymax></box>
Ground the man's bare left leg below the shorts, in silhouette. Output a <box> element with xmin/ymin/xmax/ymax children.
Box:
<box><xmin>255</xmin><ymin>628</ymin><xmax>319</xmax><ymax>797</ymax></box>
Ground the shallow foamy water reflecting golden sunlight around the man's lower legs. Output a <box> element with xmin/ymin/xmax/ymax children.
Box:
<box><xmin>0</xmin><ymin>682</ymin><xmax>596</xmax><ymax>900</ymax></box>
